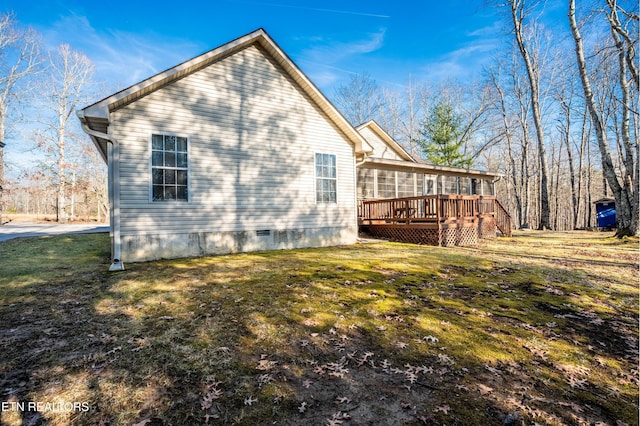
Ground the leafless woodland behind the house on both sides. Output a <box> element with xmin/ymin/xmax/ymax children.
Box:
<box><xmin>0</xmin><ymin>0</ymin><xmax>640</xmax><ymax>235</ymax></box>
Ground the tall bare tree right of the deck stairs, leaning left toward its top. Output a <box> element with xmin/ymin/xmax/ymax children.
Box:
<box><xmin>507</xmin><ymin>0</ymin><xmax>551</xmax><ymax>229</ymax></box>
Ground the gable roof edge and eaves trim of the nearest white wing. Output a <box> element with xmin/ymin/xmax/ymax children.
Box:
<box><xmin>76</xmin><ymin>28</ymin><xmax>373</xmax><ymax>161</ymax></box>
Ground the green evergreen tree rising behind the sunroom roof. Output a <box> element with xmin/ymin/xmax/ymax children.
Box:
<box><xmin>417</xmin><ymin>100</ymin><xmax>473</xmax><ymax>168</ymax></box>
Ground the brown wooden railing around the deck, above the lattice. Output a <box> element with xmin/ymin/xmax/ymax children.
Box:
<box><xmin>358</xmin><ymin>195</ymin><xmax>511</xmax><ymax>235</ymax></box>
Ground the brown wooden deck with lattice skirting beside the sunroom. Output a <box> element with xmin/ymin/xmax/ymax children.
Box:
<box><xmin>358</xmin><ymin>195</ymin><xmax>511</xmax><ymax>246</ymax></box>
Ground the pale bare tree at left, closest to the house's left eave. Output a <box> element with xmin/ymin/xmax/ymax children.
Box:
<box><xmin>36</xmin><ymin>44</ymin><xmax>94</xmax><ymax>222</ymax></box>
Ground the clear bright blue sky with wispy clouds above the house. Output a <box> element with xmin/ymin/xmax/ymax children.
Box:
<box><xmin>0</xmin><ymin>0</ymin><xmax>548</xmax><ymax>95</ymax></box>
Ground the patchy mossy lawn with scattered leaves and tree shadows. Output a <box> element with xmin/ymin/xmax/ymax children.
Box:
<box><xmin>0</xmin><ymin>232</ymin><xmax>639</xmax><ymax>426</ymax></box>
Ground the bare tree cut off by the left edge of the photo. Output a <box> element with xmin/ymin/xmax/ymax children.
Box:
<box><xmin>0</xmin><ymin>14</ymin><xmax>39</xmax><ymax>226</ymax></box>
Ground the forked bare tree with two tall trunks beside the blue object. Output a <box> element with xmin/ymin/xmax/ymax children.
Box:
<box><xmin>568</xmin><ymin>0</ymin><xmax>639</xmax><ymax>236</ymax></box>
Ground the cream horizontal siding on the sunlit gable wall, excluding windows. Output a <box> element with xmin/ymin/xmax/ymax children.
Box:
<box><xmin>111</xmin><ymin>45</ymin><xmax>357</xmax><ymax>261</ymax></box>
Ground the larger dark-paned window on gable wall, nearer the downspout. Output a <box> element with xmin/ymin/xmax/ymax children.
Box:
<box><xmin>151</xmin><ymin>134</ymin><xmax>189</xmax><ymax>201</ymax></box>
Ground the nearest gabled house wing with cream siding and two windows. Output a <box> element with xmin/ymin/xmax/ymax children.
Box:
<box><xmin>78</xmin><ymin>29</ymin><xmax>372</xmax><ymax>269</ymax></box>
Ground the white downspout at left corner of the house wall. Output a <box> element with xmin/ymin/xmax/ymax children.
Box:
<box><xmin>80</xmin><ymin>120</ymin><xmax>124</xmax><ymax>272</ymax></box>
